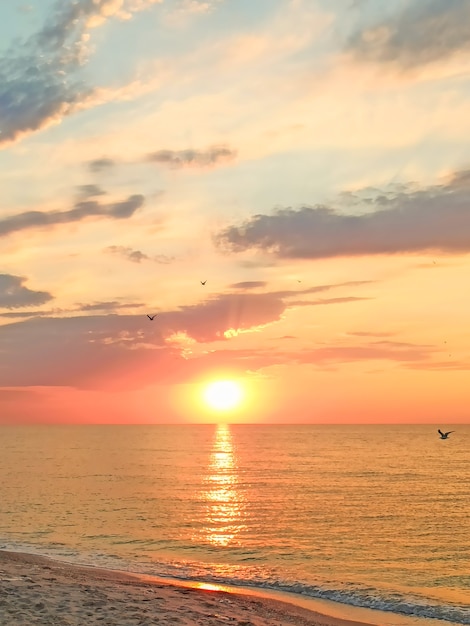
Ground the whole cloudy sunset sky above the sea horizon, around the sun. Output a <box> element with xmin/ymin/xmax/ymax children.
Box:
<box><xmin>0</xmin><ymin>0</ymin><xmax>470</xmax><ymax>426</ymax></box>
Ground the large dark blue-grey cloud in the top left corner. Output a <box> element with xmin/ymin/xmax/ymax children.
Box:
<box><xmin>0</xmin><ymin>0</ymin><xmax>164</xmax><ymax>145</ymax></box>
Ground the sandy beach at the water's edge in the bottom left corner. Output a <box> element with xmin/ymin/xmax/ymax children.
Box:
<box><xmin>0</xmin><ymin>551</ymin><xmax>374</xmax><ymax>626</ymax></box>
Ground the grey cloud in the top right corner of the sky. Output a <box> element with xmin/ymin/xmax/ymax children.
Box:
<box><xmin>347</xmin><ymin>0</ymin><xmax>470</xmax><ymax>70</ymax></box>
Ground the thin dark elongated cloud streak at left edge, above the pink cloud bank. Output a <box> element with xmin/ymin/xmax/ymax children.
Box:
<box><xmin>0</xmin><ymin>194</ymin><xmax>144</xmax><ymax>237</ymax></box>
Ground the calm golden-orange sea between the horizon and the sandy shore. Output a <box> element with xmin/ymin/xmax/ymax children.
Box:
<box><xmin>0</xmin><ymin>424</ymin><xmax>470</xmax><ymax>626</ymax></box>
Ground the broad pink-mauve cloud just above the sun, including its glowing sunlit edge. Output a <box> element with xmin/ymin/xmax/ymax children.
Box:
<box><xmin>0</xmin><ymin>283</ymin><xmax>374</xmax><ymax>389</ymax></box>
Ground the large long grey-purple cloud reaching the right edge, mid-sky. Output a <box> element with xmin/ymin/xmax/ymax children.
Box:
<box><xmin>218</xmin><ymin>171</ymin><xmax>470</xmax><ymax>259</ymax></box>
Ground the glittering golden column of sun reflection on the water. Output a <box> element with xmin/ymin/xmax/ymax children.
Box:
<box><xmin>202</xmin><ymin>424</ymin><xmax>245</xmax><ymax>546</ymax></box>
